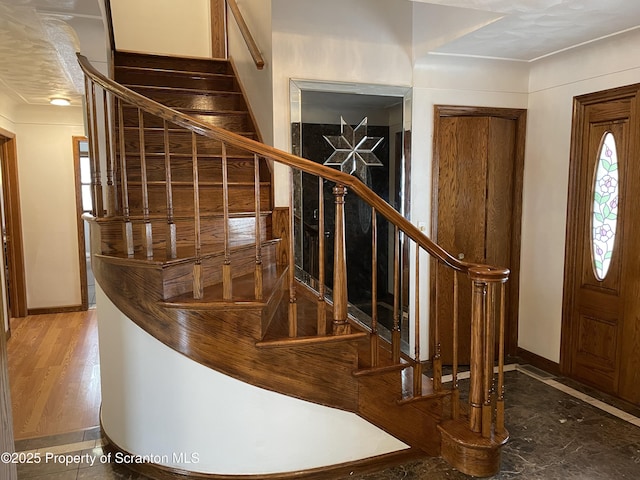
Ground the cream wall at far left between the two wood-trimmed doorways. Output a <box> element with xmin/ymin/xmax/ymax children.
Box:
<box><xmin>14</xmin><ymin>105</ymin><xmax>84</xmax><ymax>309</ymax></box>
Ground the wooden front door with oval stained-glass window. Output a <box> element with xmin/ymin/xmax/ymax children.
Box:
<box><xmin>562</xmin><ymin>85</ymin><xmax>640</xmax><ymax>404</ymax></box>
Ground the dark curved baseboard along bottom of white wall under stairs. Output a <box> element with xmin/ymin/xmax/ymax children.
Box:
<box><xmin>101</xmin><ymin>432</ymin><xmax>425</xmax><ymax>480</ymax></box>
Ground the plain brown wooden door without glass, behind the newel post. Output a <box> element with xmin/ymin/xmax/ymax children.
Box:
<box><xmin>431</xmin><ymin>107</ymin><xmax>525</xmax><ymax>364</ymax></box>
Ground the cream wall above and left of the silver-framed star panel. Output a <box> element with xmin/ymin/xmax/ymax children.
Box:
<box><xmin>272</xmin><ymin>0</ymin><xmax>412</xmax><ymax>206</ymax></box>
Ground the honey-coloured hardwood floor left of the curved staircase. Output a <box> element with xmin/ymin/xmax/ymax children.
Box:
<box><xmin>7</xmin><ymin>310</ymin><xmax>101</xmax><ymax>440</ymax></box>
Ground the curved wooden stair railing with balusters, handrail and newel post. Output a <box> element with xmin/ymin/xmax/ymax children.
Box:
<box><xmin>78</xmin><ymin>55</ymin><xmax>509</xmax><ymax>440</ymax></box>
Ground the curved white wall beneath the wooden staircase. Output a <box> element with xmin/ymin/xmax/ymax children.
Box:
<box><xmin>97</xmin><ymin>288</ymin><xmax>409</xmax><ymax>475</ymax></box>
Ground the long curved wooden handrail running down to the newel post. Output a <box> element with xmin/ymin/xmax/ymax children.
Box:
<box><xmin>78</xmin><ymin>54</ymin><xmax>500</xmax><ymax>279</ymax></box>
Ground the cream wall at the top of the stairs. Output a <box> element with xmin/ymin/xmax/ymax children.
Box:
<box><xmin>111</xmin><ymin>0</ymin><xmax>211</xmax><ymax>58</ymax></box>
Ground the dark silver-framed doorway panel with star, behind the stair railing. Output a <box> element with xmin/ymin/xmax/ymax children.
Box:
<box><xmin>290</xmin><ymin>80</ymin><xmax>411</xmax><ymax>352</ymax></box>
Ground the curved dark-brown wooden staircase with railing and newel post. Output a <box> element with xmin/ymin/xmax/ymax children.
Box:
<box><xmin>80</xmin><ymin>52</ymin><xmax>508</xmax><ymax>476</ymax></box>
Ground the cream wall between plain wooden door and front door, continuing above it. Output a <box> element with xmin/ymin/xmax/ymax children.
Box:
<box><xmin>518</xmin><ymin>30</ymin><xmax>640</xmax><ymax>362</ymax></box>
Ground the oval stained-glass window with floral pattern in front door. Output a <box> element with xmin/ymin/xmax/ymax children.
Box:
<box><xmin>591</xmin><ymin>132</ymin><xmax>619</xmax><ymax>281</ymax></box>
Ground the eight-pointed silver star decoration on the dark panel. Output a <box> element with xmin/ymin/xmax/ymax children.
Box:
<box><xmin>323</xmin><ymin>117</ymin><xmax>384</xmax><ymax>181</ymax></box>
